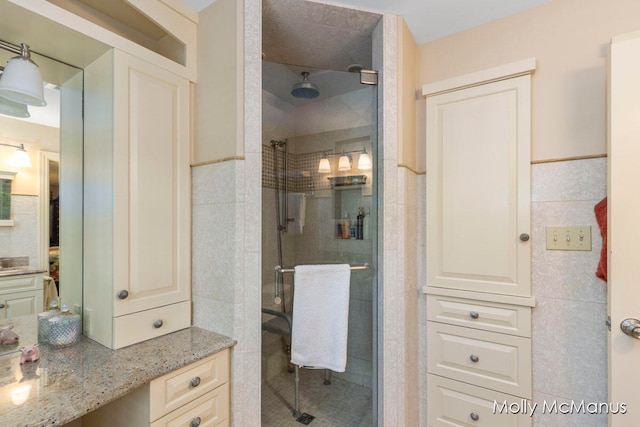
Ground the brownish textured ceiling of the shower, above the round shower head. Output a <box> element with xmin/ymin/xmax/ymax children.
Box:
<box><xmin>262</xmin><ymin>0</ymin><xmax>381</xmax><ymax>71</ymax></box>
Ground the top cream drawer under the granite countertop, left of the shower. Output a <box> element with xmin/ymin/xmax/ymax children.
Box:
<box><xmin>149</xmin><ymin>350</ymin><xmax>229</xmax><ymax>425</ymax></box>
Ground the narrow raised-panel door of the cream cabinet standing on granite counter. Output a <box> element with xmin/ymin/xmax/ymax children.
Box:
<box><xmin>113</xmin><ymin>51</ymin><xmax>191</xmax><ymax>316</ymax></box>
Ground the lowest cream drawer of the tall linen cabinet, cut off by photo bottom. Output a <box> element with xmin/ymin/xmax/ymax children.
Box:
<box><xmin>427</xmin><ymin>375</ymin><xmax>532</xmax><ymax>427</ymax></box>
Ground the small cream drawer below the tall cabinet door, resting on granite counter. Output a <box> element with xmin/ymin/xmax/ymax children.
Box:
<box><xmin>113</xmin><ymin>301</ymin><xmax>191</xmax><ymax>349</ymax></box>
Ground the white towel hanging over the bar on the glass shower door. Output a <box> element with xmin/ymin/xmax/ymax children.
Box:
<box><xmin>291</xmin><ymin>264</ymin><xmax>351</xmax><ymax>372</ymax></box>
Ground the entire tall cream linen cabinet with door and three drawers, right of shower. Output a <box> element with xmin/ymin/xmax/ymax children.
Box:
<box><xmin>423</xmin><ymin>59</ymin><xmax>535</xmax><ymax>427</ymax></box>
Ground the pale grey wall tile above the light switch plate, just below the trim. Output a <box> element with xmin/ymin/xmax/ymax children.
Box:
<box><xmin>531</xmin><ymin>158</ymin><xmax>607</xmax><ymax>202</ymax></box>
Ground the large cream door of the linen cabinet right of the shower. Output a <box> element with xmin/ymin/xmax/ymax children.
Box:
<box><xmin>427</xmin><ymin>75</ymin><xmax>531</xmax><ymax>296</ymax></box>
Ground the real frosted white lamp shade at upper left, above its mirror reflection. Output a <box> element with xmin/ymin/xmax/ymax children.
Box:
<box><xmin>0</xmin><ymin>56</ymin><xmax>47</xmax><ymax>107</ymax></box>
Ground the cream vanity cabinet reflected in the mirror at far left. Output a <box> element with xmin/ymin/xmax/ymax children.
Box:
<box><xmin>0</xmin><ymin>273</ymin><xmax>43</xmax><ymax>319</ymax></box>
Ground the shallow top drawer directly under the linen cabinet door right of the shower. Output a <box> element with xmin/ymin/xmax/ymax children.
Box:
<box><xmin>427</xmin><ymin>295</ymin><xmax>531</xmax><ymax>337</ymax></box>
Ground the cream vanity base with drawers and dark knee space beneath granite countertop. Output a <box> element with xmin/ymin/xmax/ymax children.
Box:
<box><xmin>82</xmin><ymin>349</ymin><xmax>230</xmax><ymax>427</ymax></box>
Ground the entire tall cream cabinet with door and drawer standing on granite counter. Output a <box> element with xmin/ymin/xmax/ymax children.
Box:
<box><xmin>84</xmin><ymin>50</ymin><xmax>191</xmax><ymax>348</ymax></box>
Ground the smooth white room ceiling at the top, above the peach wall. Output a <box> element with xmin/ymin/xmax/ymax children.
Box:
<box><xmin>182</xmin><ymin>0</ymin><xmax>549</xmax><ymax>44</ymax></box>
